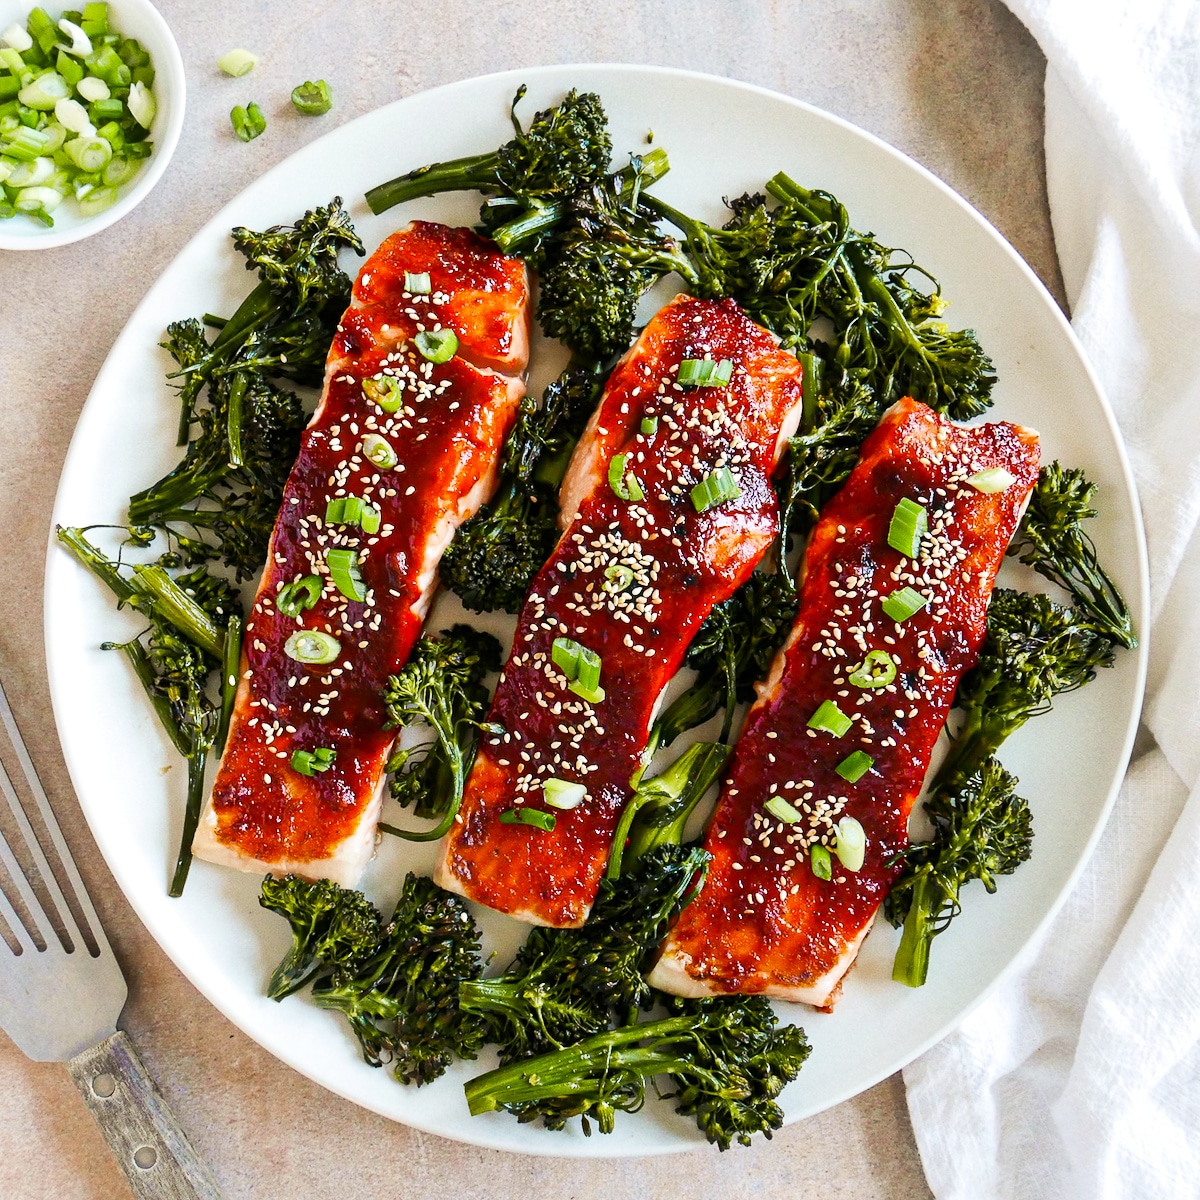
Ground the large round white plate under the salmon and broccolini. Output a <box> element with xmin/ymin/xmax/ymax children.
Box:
<box><xmin>46</xmin><ymin>66</ymin><xmax>1146</xmax><ymax>1156</ymax></box>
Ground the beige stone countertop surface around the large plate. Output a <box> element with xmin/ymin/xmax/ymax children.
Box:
<box><xmin>0</xmin><ymin>0</ymin><xmax>1062</xmax><ymax>1200</ymax></box>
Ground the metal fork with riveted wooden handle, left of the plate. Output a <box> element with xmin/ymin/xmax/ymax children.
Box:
<box><xmin>0</xmin><ymin>686</ymin><xmax>221</xmax><ymax>1200</ymax></box>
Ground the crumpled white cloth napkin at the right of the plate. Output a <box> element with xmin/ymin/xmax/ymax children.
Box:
<box><xmin>905</xmin><ymin>0</ymin><xmax>1200</xmax><ymax>1200</ymax></box>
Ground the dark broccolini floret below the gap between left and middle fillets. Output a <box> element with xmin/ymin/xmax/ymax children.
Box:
<box><xmin>312</xmin><ymin>874</ymin><xmax>485</xmax><ymax>1086</ymax></box>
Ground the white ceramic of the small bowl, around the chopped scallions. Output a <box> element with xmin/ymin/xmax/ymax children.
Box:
<box><xmin>0</xmin><ymin>0</ymin><xmax>187</xmax><ymax>250</ymax></box>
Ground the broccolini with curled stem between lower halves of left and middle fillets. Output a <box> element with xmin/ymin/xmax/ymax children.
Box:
<box><xmin>380</xmin><ymin>625</ymin><xmax>500</xmax><ymax>841</ymax></box>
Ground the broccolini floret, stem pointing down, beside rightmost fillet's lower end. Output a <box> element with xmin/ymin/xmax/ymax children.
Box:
<box><xmin>884</xmin><ymin>757</ymin><xmax>1033</xmax><ymax>988</ymax></box>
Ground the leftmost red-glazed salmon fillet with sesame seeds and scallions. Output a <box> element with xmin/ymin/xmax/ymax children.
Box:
<box><xmin>192</xmin><ymin>222</ymin><xmax>529</xmax><ymax>887</ymax></box>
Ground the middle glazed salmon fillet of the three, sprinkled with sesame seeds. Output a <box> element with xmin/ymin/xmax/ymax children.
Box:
<box><xmin>434</xmin><ymin>296</ymin><xmax>802</xmax><ymax>926</ymax></box>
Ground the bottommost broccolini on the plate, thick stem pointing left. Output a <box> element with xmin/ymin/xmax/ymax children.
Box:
<box><xmin>466</xmin><ymin>996</ymin><xmax>809</xmax><ymax>1150</ymax></box>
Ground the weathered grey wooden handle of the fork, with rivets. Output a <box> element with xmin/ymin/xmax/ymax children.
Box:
<box><xmin>67</xmin><ymin>1030</ymin><xmax>221</xmax><ymax>1200</ymax></box>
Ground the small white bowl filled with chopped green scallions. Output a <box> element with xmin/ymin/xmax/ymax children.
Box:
<box><xmin>0</xmin><ymin>0</ymin><xmax>185</xmax><ymax>250</ymax></box>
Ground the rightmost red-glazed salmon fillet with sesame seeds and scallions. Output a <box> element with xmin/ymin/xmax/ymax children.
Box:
<box><xmin>649</xmin><ymin>400</ymin><xmax>1038</xmax><ymax>1008</ymax></box>
